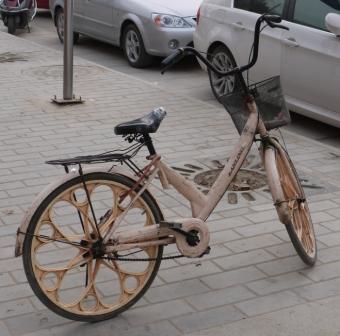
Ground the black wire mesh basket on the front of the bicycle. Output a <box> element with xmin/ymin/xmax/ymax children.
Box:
<box><xmin>220</xmin><ymin>76</ymin><xmax>290</xmax><ymax>134</ymax></box>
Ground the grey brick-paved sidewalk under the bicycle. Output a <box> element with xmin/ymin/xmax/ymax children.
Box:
<box><xmin>0</xmin><ymin>33</ymin><xmax>340</xmax><ymax>336</ymax></box>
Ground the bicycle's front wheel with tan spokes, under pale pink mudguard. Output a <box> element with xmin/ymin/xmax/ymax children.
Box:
<box><xmin>265</xmin><ymin>143</ymin><xmax>317</xmax><ymax>266</ymax></box>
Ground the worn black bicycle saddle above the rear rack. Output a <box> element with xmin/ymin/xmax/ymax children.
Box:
<box><xmin>114</xmin><ymin>107</ymin><xmax>166</xmax><ymax>135</ymax></box>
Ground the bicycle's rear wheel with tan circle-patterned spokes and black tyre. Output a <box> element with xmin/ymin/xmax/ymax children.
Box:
<box><xmin>23</xmin><ymin>172</ymin><xmax>163</xmax><ymax>322</ymax></box>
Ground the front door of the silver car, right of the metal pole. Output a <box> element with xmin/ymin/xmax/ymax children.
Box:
<box><xmin>83</xmin><ymin>0</ymin><xmax>118</xmax><ymax>42</ymax></box>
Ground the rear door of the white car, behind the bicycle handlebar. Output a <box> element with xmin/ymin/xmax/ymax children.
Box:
<box><xmin>232</xmin><ymin>0</ymin><xmax>288</xmax><ymax>81</ymax></box>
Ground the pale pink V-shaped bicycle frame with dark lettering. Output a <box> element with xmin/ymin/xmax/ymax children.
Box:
<box><xmin>103</xmin><ymin>100</ymin><xmax>286</xmax><ymax>250</ymax></box>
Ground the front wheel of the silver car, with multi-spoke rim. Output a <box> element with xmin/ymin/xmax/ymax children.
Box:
<box><xmin>122</xmin><ymin>24</ymin><xmax>153</xmax><ymax>68</ymax></box>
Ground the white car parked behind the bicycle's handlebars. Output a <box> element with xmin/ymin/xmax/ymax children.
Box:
<box><xmin>194</xmin><ymin>0</ymin><xmax>340</xmax><ymax>127</ymax></box>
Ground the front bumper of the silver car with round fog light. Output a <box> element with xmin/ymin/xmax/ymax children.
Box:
<box><xmin>143</xmin><ymin>24</ymin><xmax>195</xmax><ymax>56</ymax></box>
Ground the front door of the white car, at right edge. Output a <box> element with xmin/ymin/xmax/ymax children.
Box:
<box><xmin>281</xmin><ymin>0</ymin><xmax>340</xmax><ymax>122</ymax></box>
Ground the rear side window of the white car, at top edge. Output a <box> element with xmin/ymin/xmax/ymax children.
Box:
<box><xmin>234</xmin><ymin>0</ymin><xmax>285</xmax><ymax>16</ymax></box>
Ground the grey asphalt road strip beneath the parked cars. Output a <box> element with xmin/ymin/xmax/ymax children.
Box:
<box><xmin>0</xmin><ymin>11</ymin><xmax>340</xmax><ymax>148</ymax></box>
